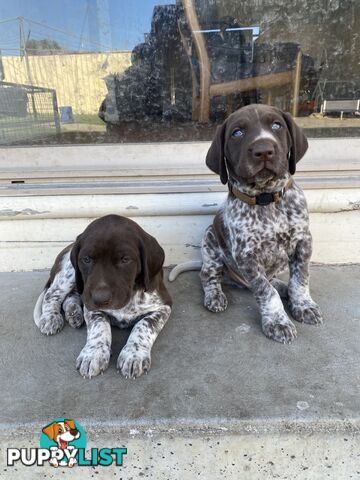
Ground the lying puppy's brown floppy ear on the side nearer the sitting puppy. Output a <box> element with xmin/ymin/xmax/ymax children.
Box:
<box><xmin>138</xmin><ymin>231</ymin><xmax>165</xmax><ymax>291</ymax></box>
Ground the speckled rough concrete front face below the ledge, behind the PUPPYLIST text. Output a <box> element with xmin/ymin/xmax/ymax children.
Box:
<box><xmin>0</xmin><ymin>430</ymin><xmax>359</xmax><ymax>480</ymax></box>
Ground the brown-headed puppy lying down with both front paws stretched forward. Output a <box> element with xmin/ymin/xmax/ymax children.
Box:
<box><xmin>34</xmin><ymin>215</ymin><xmax>171</xmax><ymax>378</ymax></box>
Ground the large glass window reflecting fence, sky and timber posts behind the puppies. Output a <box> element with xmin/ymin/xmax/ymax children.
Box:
<box><xmin>0</xmin><ymin>0</ymin><xmax>360</xmax><ymax>145</ymax></box>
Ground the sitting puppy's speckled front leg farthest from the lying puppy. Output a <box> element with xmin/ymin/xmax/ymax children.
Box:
<box><xmin>288</xmin><ymin>232</ymin><xmax>323</xmax><ymax>325</ymax></box>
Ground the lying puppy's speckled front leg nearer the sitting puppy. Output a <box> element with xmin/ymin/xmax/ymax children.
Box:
<box><xmin>117</xmin><ymin>305</ymin><xmax>171</xmax><ymax>378</ymax></box>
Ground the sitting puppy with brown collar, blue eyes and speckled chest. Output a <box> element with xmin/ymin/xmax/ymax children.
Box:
<box><xmin>169</xmin><ymin>105</ymin><xmax>322</xmax><ymax>343</ymax></box>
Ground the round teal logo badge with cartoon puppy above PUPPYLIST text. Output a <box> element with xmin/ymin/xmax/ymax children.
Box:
<box><xmin>40</xmin><ymin>419</ymin><xmax>86</xmax><ymax>467</ymax></box>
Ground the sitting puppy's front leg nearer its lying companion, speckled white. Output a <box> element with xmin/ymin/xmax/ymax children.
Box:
<box><xmin>238</xmin><ymin>256</ymin><xmax>296</xmax><ymax>343</ymax></box>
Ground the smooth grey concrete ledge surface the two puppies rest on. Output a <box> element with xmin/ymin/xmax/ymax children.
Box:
<box><xmin>0</xmin><ymin>266</ymin><xmax>360</xmax><ymax>430</ymax></box>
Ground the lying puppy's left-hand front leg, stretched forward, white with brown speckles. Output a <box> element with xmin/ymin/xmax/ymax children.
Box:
<box><xmin>76</xmin><ymin>306</ymin><xmax>111</xmax><ymax>378</ymax></box>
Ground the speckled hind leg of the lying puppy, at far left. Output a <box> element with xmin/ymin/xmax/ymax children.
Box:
<box><xmin>34</xmin><ymin>252</ymin><xmax>75</xmax><ymax>335</ymax></box>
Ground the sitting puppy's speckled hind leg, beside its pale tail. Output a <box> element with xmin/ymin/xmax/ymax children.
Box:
<box><xmin>200</xmin><ymin>225</ymin><xmax>227</xmax><ymax>312</ymax></box>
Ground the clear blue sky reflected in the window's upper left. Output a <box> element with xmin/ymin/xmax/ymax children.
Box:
<box><xmin>0</xmin><ymin>0</ymin><xmax>175</xmax><ymax>55</ymax></box>
